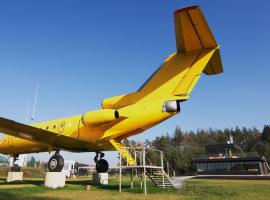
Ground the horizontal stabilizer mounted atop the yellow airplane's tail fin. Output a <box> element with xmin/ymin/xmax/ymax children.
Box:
<box><xmin>174</xmin><ymin>6</ymin><xmax>223</xmax><ymax>75</ymax></box>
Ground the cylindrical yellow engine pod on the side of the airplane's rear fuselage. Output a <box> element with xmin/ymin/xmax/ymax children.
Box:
<box><xmin>82</xmin><ymin>109</ymin><xmax>119</xmax><ymax>126</ymax></box>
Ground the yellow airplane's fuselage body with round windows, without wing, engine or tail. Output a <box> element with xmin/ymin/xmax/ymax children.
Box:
<box><xmin>0</xmin><ymin>97</ymin><xmax>176</xmax><ymax>155</ymax></box>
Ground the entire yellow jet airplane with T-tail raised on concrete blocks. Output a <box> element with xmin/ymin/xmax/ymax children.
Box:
<box><xmin>0</xmin><ymin>6</ymin><xmax>223</xmax><ymax>172</ymax></box>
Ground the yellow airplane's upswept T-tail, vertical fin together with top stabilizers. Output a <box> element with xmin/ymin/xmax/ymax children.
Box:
<box><xmin>102</xmin><ymin>6</ymin><xmax>223</xmax><ymax>108</ymax></box>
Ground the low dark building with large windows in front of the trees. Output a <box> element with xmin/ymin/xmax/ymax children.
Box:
<box><xmin>193</xmin><ymin>144</ymin><xmax>270</xmax><ymax>175</ymax></box>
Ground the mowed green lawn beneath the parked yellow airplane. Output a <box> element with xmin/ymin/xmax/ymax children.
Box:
<box><xmin>0</xmin><ymin>178</ymin><xmax>270</xmax><ymax>200</ymax></box>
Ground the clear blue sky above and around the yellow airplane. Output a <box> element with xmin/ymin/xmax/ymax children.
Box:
<box><xmin>0</xmin><ymin>0</ymin><xmax>270</xmax><ymax>162</ymax></box>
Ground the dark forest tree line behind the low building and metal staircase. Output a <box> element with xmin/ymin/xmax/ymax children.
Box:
<box><xmin>132</xmin><ymin>125</ymin><xmax>270</xmax><ymax>174</ymax></box>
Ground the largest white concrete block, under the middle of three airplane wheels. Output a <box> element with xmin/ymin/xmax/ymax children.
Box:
<box><xmin>44</xmin><ymin>172</ymin><xmax>66</xmax><ymax>189</ymax></box>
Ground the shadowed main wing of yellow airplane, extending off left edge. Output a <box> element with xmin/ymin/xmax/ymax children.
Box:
<box><xmin>0</xmin><ymin>117</ymin><xmax>87</xmax><ymax>151</ymax></box>
